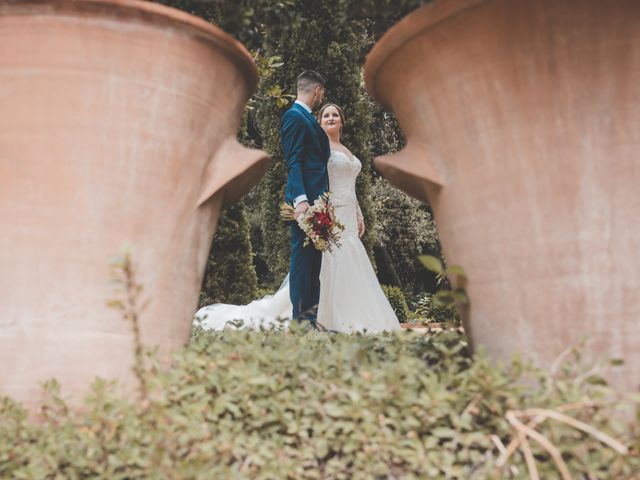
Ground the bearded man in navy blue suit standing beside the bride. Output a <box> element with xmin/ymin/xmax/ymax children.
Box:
<box><xmin>280</xmin><ymin>70</ymin><xmax>331</xmax><ymax>328</ymax></box>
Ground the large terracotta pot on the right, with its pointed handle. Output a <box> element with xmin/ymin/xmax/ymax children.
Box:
<box><xmin>365</xmin><ymin>0</ymin><xmax>640</xmax><ymax>390</ymax></box>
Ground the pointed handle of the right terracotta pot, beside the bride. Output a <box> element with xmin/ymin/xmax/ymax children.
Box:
<box><xmin>374</xmin><ymin>144</ymin><xmax>444</xmax><ymax>201</ymax></box>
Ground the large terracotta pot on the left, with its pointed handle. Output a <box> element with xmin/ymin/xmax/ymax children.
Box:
<box><xmin>0</xmin><ymin>0</ymin><xmax>268</xmax><ymax>404</ymax></box>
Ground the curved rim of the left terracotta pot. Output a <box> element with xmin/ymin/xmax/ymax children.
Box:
<box><xmin>0</xmin><ymin>0</ymin><xmax>258</xmax><ymax>99</ymax></box>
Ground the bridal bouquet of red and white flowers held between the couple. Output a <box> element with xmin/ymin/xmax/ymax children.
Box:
<box><xmin>280</xmin><ymin>192</ymin><xmax>344</xmax><ymax>252</ymax></box>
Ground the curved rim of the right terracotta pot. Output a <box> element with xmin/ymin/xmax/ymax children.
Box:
<box><xmin>364</xmin><ymin>0</ymin><xmax>486</xmax><ymax>110</ymax></box>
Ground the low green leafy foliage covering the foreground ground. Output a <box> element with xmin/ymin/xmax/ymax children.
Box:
<box><xmin>0</xmin><ymin>331</ymin><xmax>640</xmax><ymax>479</ymax></box>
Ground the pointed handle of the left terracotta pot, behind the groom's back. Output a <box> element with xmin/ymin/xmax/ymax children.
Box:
<box><xmin>197</xmin><ymin>137</ymin><xmax>270</xmax><ymax>208</ymax></box>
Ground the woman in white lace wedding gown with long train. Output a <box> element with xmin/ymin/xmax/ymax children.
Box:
<box><xmin>194</xmin><ymin>104</ymin><xmax>400</xmax><ymax>333</ymax></box>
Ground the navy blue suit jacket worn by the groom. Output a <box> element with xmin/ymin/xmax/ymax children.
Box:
<box><xmin>280</xmin><ymin>103</ymin><xmax>331</xmax><ymax>205</ymax></box>
